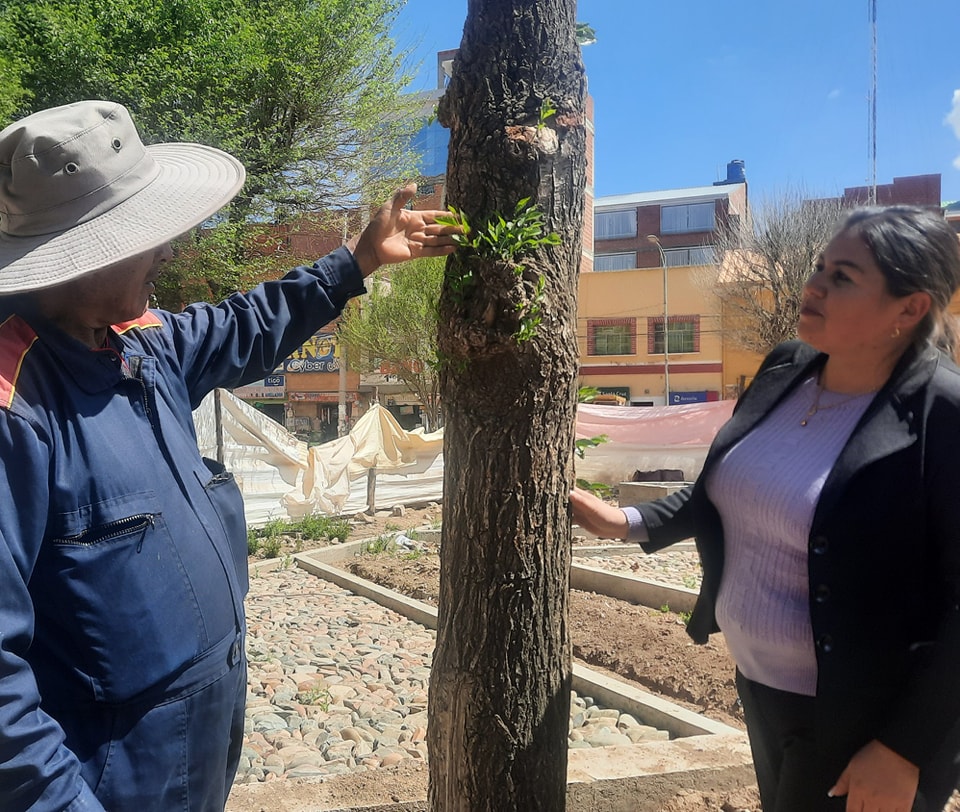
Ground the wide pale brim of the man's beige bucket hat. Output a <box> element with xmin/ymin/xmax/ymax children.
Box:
<box><xmin>0</xmin><ymin>143</ymin><xmax>245</xmax><ymax>295</ymax></box>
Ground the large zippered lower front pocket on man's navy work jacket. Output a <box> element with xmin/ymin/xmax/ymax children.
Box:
<box><xmin>37</xmin><ymin>492</ymin><xmax>208</xmax><ymax>702</ymax></box>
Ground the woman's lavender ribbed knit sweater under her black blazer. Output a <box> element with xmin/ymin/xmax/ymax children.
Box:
<box><xmin>624</xmin><ymin>377</ymin><xmax>873</xmax><ymax>696</ymax></box>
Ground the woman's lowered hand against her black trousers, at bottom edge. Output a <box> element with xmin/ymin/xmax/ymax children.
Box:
<box><xmin>827</xmin><ymin>739</ymin><xmax>920</xmax><ymax>812</ymax></box>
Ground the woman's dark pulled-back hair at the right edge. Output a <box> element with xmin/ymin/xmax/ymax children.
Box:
<box><xmin>837</xmin><ymin>206</ymin><xmax>960</xmax><ymax>358</ymax></box>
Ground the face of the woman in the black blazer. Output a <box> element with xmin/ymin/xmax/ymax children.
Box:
<box><xmin>797</xmin><ymin>232</ymin><xmax>903</xmax><ymax>356</ymax></box>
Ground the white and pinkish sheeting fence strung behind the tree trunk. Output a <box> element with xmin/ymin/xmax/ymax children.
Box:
<box><xmin>194</xmin><ymin>390</ymin><xmax>733</xmax><ymax>525</ymax></box>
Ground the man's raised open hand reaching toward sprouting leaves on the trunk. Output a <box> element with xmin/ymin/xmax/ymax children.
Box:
<box><xmin>347</xmin><ymin>183</ymin><xmax>462</xmax><ymax>276</ymax></box>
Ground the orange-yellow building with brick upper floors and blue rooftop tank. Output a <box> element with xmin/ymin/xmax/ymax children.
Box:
<box><xmin>577</xmin><ymin>160</ymin><xmax>747</xmax><ymax>406</ymax></box>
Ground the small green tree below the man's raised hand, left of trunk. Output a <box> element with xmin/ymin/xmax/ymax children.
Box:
<box><xmin>339</xmin><ymin>258</ymin><xmax>444</xmax><ymax>430</ymax></box>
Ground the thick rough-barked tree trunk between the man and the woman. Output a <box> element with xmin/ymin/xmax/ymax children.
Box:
<box><xmin>428</xmin><ymin>0</ymin><xmax>586</xmax><ymax>812</ymax></box>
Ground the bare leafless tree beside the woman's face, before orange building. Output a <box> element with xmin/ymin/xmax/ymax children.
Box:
<box><xmin>711</xmin><ymin>189</ymin><xmax>841</xmax><ymax>354</ymax></box>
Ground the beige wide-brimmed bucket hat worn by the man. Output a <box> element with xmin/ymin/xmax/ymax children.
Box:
<box><xmin>0</xmin><ymin>101</ymin><xmax>244</xmax><ymax>294</ymax></box>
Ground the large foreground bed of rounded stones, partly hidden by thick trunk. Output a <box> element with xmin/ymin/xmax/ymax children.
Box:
<box><xmin>236</xmin><ymin>567</ymin><xmax>669</xmax><ymax>783</ymax></box>
